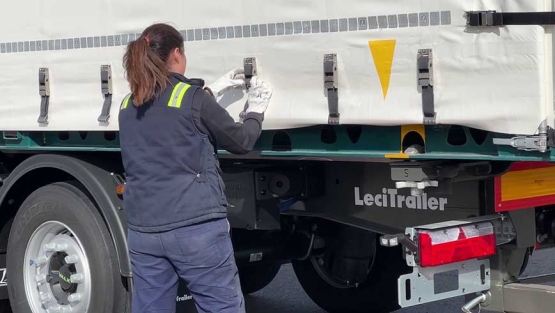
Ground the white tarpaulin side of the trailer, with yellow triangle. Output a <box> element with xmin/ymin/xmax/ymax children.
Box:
<box><xmin>0</xmin><ymin>0</ymin><xmax>554</xmax><ymax>134</ymax></box>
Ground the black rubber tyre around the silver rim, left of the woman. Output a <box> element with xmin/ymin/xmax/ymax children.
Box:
<box><xmin>7</xmin><ymin>182</ymin><xmax>128</xmax><ymax>313</ymax></box>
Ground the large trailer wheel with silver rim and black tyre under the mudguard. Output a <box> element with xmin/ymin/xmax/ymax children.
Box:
<box><xmin>7</xmin><ymin>182</ymin><xmax>127</xmax><ymax>313</ymax></box>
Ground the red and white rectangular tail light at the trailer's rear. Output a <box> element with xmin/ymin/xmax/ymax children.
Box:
<box><xmin>418</xmin><ymin>223</ymin><xmax>496</xmax><ymax>267</ymax></box>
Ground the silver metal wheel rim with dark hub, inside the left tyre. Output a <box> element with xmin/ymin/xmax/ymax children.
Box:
<box><xmin>23</xmin><ymin>221</ymin><xmax>91</xmax><ymax>313</ymax></box>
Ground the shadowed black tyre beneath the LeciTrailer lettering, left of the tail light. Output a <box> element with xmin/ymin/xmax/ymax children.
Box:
<box><xmin>292</xmin><ymin>240</ymin><xmax>408</xmax><ymax>313</ymax></box>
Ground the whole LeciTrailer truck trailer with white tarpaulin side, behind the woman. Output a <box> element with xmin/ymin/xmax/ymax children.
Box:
<box><xmin>0</xmin><ymin>0</ymin><xmax>555</xmax><ymax>313</ymax></box>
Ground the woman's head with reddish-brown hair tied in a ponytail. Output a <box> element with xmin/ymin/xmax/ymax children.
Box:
<box><xmin>123</xmin><ymin>24</ymin><xmax>187</xmax><ymax>105</ymax></box>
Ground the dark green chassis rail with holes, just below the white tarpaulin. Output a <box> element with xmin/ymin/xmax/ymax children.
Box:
<box><xmin>0</xmin><ymin>125</ymin><xmax>555</xmax><ymax>161</ymax></box>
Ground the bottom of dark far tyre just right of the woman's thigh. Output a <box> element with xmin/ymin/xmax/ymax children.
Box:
<box><xmin>239</xmin><ymin>263</ymin><xmax>281</xmax><ymax>295</ymax></box>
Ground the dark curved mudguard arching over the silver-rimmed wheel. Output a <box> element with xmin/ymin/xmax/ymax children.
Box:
<box><xmin>0</xmin><ymin>154</ymin><xmax>132</xmax><ymax>277</ymax></box>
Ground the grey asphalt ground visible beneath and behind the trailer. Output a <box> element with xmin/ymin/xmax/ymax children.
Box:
<box><xmin>246</xmin><ymin>249</ymin><xmax>555</xmax><ymax>313</ymax></box>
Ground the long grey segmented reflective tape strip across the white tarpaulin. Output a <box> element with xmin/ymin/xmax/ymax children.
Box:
<box><xmin>0</xmin><ymin>10</ymin><xmax>452</xmax><ymax>54</ymax></box>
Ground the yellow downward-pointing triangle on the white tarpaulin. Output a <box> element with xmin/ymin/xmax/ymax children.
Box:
<box><xmin>368</xmin><ymin>40</ymin><xmax>397</xmax><ymax>99</ymax></box>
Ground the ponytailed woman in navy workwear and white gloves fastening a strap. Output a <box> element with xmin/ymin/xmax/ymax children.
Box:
<box><xmin>119</xmin><ymin>24</ymin><xmax>272</xmax><ymax>313</ymax></box>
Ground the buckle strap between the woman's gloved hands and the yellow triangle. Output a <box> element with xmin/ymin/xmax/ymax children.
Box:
<box><xmin>324</xmin><ymin>53</ymin><xmax>340</xmax><ymax>125</ymax></box>
